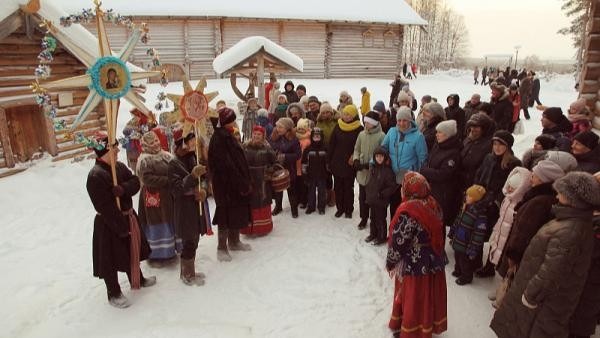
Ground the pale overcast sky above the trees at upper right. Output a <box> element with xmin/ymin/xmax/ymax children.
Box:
<box><xmin>446</xmin><ymin>0</ymin><xmax>575</xmax><ymax>59</ymax></box>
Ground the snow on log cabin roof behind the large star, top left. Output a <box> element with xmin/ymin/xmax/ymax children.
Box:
<box><xmin>0</xmin><ymin>0</ymin><xmax>143</xmax><ymax>71</ymax></box>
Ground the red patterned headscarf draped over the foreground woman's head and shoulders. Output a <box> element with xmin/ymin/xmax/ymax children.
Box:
<box><xmin>388</xmin><ymin>171</ymin><xmax>444</xmax><ymax>255</ymax></box>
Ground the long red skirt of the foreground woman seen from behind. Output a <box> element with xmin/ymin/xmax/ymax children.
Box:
<box><xmin>389</xmin><ymin>271</ymin><xmax>448</xmax><ymax>338</ymax></box>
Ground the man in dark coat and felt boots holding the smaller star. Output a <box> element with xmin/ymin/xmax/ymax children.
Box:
<box><xmin>168</xmin><ymin>129</ymin><xmax>210</xmax><ymax>285</ymax></box>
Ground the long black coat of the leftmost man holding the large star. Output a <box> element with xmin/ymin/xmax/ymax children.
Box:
<box><xmin>86</xmin><ymin>160</ymin><xmax>150</xmax><ymax>278</ymax></box>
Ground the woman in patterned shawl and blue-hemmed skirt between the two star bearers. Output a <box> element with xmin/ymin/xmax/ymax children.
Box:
<box><xmin>136</xmin><ymin>131</ymin><xmax>181</xmax><ymax>266</ymax></box>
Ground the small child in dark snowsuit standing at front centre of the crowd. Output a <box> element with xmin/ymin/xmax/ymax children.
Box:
<box><xmin>302</xmin><ymin>127</ymin><xmax>329</xmax><ymax>215</ymax></box>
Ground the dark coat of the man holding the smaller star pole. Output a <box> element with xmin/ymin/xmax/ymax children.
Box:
<box><xmin>168</xmin><ymin>153</ymin><xmax>209</xmax><ymax>242</ymax></box>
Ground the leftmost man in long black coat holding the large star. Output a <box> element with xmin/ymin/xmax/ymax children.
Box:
<box><xmin>86</xmin><ymin>132</ymin><xmax>156</xmax><ymax>308</ymax></box>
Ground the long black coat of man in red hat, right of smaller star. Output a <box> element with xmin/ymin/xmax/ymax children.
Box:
<box><xmin>208</xmin><ymin>128</ymin><xmax>252</xmax><ymax>229</ymax></box>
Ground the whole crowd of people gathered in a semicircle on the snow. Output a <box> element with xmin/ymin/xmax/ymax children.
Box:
<box><xmin>88</xmin><ymin>69</ymin><xmax>600</xmax><ymax>337</ymax></box>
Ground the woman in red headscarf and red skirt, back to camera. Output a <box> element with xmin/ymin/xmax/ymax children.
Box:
<box><xmin>386</xmin><ymin>172</ymin><xmax>448</xmax><ymax>338</ymax></box>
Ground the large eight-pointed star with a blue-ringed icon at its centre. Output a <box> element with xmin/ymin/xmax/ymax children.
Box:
<box><xmin>42</xmin><ymin>0</ymin><xmax>160</xmax><ymax>137</ymax></box>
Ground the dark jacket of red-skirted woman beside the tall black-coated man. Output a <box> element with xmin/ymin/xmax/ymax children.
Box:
<box><xmin>243</xmin><ymin>143</ymin><xmax>276</xmax><ymax>209</ymax></box>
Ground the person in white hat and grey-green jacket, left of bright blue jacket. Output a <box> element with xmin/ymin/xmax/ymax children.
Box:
<box><xmin>352</xmin><ymin>111</ymin><xmax>385</xmax><ymax>230</ymax></box>
